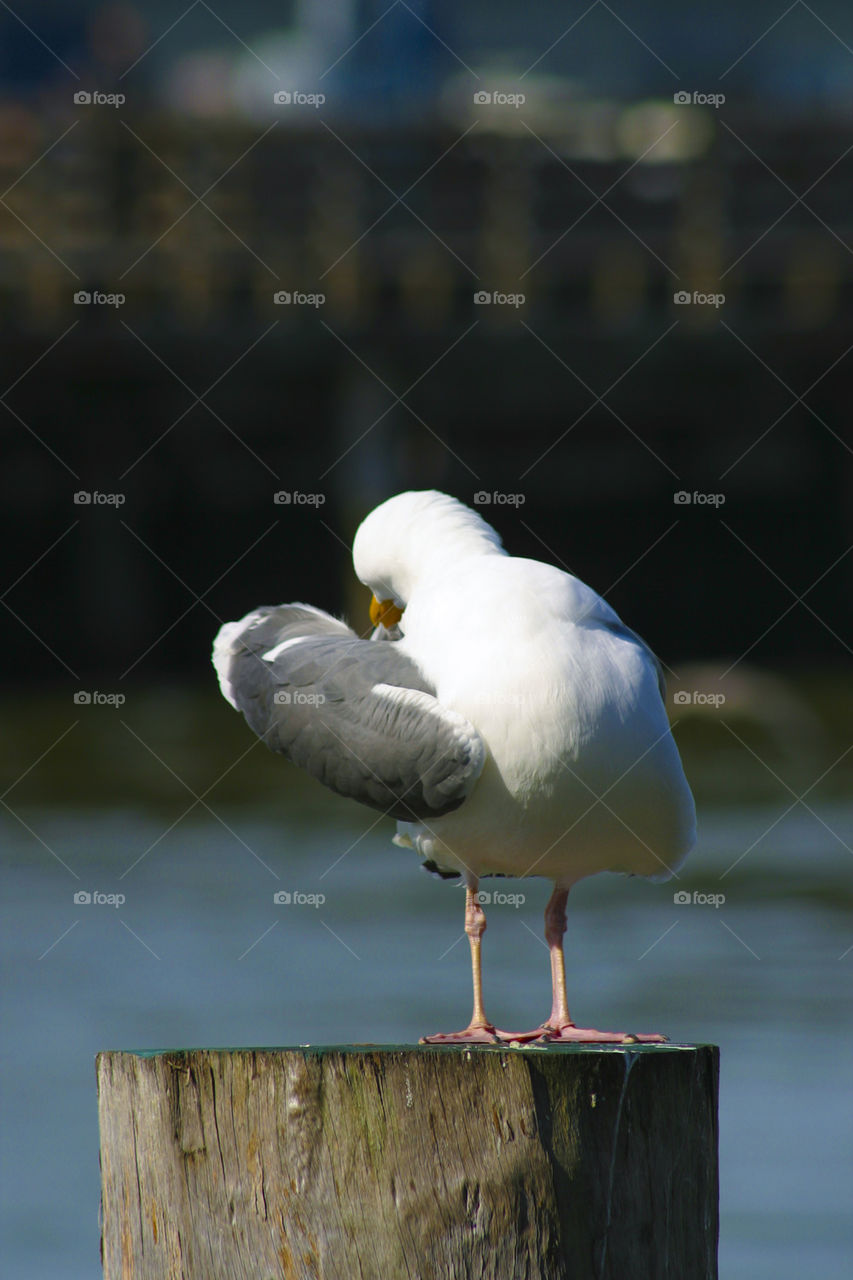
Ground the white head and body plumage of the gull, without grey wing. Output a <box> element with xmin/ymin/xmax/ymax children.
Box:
<box><xmin>353</xmin><ymin>493</ymin><xmax>695</xmax><ymax>888</ymax></box>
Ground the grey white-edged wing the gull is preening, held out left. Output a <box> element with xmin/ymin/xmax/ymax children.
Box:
<box><xmin>214</xmin><ymin>604</ymin><xmax>485</xmax><ymax>822</ymax></box>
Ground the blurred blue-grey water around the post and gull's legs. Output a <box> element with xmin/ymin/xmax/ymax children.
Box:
<box><xmin>1</xmin><ymin>800</ymin><xmax>853</xmax><ymax>1280</ymax></box>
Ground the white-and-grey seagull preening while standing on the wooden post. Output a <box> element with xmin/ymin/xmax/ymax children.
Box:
<box><xmin>213</xmin><ymin>490</ymin><xmax>695</xmax><ymax>1044</ymax></box>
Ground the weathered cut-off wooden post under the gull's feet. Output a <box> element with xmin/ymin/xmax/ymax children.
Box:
<box><xmin>97</xmin><ymin>1044</ymin><xmax>719</xmax><ymax>1280</ymax></box>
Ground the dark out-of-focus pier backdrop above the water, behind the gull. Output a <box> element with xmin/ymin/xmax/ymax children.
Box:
<box><xmin>0</xmin><ymin>0</ymin><xmax>853</xmax><ymax>684</ymax></box>
